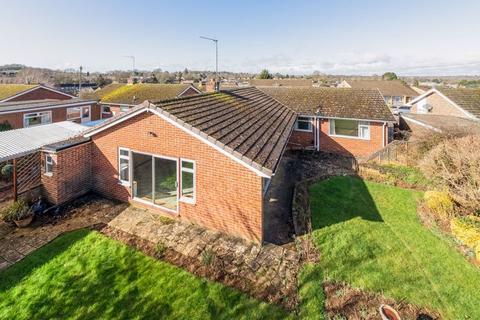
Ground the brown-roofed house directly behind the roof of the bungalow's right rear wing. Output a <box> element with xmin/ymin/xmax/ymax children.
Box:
<box><xmin>338</xmin><ymin>80</ymin><xmax>419</xmax><ymax>107</ymax></box>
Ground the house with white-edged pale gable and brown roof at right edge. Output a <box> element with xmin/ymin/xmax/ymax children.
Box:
<box><xmin>409</xmin><ymin>87</ymin><xmax>480</xmax><ymax>120</ymax></box>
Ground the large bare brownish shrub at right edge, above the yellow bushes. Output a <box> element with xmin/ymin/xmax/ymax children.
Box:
<box><xmin>420</xmin><ymin>135</ymin><xmax>480</xmax><ymax>208</ymax></box>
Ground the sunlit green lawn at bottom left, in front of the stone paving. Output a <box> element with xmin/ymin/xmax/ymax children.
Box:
<box><xmin>0</xmin><ymin>230</ymin><xmax>289</xmax><ymax>319</ymax></box>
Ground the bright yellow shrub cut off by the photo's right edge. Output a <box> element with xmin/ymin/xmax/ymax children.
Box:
<box><xmin>450</xmin><ymin>216</ymin><xmax>480</xmax><ymax>261</ymax></box>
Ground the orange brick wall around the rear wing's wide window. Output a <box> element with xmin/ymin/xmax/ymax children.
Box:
<box><xmin>320</xmin><ymin>119</ymin><xmax>388</xmax><ymax>157</ymax></box>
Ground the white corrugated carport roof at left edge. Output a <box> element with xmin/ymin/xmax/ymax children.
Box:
<box><xmin>0</xmin><ymin>121</ymin><xmax>87</xmax><ymax>162</ymax></box>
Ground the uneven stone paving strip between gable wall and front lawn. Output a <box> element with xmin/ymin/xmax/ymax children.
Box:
<box><xmin>104</xmin><ymin>206</ymin><xmax>300</xmax><ymax>308</ymax></box>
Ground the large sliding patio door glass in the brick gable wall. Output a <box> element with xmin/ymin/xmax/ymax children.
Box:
<box><xmin>132</xmin><ymin>152</ymin><xmax>178</xmax><ymax>211</ymax></box>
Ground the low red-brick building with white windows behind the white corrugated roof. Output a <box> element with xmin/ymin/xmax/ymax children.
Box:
<box><xmin>0</xmin><ymin>98</ymin><xmax>100</xmax><ymax>129</ymax></box>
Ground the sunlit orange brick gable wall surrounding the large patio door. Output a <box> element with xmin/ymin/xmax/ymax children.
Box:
<box><xmin>92</xmin><ymin>113</ymin><xmax>262</xmax><ymax>241</ymax></box>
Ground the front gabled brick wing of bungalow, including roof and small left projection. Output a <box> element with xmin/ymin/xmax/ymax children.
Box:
<box><xmin>42</xmin><ymin>88</ymin><xmax>296</xmax><ymax>242</ymax></box>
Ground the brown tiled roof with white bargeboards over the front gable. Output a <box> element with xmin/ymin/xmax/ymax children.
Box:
<box><xmin>86</xmin><ymin>87</ymin><xmax>296</xmax><ymax>176</ymax></box>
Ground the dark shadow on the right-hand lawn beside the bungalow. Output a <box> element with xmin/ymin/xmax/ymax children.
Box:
<box><xmin>310</xmin><ymin>176</ymin><xmax>383</xmax><ymax>230</ymax></box>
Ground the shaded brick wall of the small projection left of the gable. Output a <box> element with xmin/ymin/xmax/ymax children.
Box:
<box><xmin>41</xmin><ymin>142</ymin><xmax>91</xmax><ymax>204</ymax></box>
